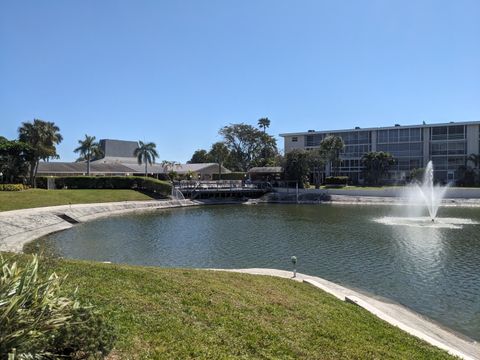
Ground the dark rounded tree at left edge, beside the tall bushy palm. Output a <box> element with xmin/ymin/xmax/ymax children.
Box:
<box><xmin>0</xmin><ymin>137</ymin><xmax>33</xmax><ymax>183</ymax></box>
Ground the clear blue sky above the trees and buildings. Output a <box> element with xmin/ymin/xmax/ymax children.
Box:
<box><xmin>0</xmin><ymin>0</ymin><xmax>480</xmax><ymax>162</ymax></box>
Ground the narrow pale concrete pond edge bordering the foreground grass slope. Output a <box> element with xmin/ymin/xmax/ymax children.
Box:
<box><xmin>213</xmin><ymin>268</ymin><xmax>480</xmax><ymax>360</ymax></box>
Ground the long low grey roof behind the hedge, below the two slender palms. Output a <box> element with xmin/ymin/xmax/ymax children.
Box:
<box><xmin>38</xmin><ymin>162</ymin><xmax>132</xmax><ymax>175</ymax></box>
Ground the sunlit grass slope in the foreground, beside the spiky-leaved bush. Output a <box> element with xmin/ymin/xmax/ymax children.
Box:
<box><xmin>32</xmin><ymin>260</ymin><xmax>451</xmax><ymax>359</ymax></box>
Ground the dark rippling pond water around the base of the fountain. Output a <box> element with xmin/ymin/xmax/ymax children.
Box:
<box><xmin>34</xmin><ymin>205</ymin><xmax>480</xmax><ymax>340</ymax></box>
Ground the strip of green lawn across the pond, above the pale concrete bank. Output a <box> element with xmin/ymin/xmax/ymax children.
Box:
<box><xmin>0</xmin><ymin>189</ymin><xmax>152</xmax><ymax>211</ymax></box>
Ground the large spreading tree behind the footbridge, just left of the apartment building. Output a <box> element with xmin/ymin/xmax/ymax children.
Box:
<box><xmin>219</xmin><ymin>123</ymin><xmax>278</xmax><ymax>171</ymax></box>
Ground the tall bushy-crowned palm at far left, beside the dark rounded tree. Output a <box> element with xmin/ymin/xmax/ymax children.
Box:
<box><xmin>18</xmin><ymin>119</ymin><xmax>63</xmax><ymax>187</ymax></box>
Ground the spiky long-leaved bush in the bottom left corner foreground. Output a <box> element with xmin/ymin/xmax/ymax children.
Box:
<box><xmin>0</xmin><ymin>256</ymin><xmax>113</xmax><ymax>359</ymax></box>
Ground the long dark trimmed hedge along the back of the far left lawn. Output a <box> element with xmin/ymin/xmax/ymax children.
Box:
<box><xmin>37</xmin><ymin>176</ymin><xmax>172</xmax><ymax>196</ymax></box>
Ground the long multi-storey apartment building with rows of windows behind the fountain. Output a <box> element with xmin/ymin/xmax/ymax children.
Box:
<box><xmin>280</xmin><ymin>121</ymin><xmax>480</xmax><ymax>183</ymax></box>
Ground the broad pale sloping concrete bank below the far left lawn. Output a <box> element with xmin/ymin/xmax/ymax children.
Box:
<box><xmin>0</xmin><ymin>200</ymin><xmax>201</xmax><ymax>252</ymax></box>
